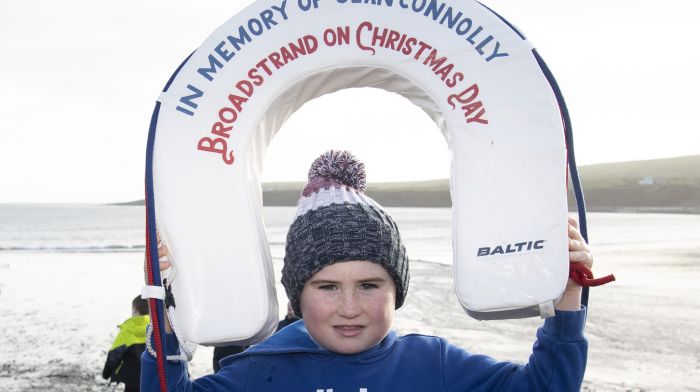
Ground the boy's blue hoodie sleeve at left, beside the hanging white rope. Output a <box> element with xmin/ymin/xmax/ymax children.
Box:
<box><xmin>141</xmin><ymin>334</ymin><xmax>248</xmax><ymax>392</ymax></box>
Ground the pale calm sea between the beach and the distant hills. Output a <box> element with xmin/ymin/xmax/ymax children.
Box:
<box><xmin>0</xmin><ymin>204</ymin><xmax>700</xmax><ymax>264</ymax></box>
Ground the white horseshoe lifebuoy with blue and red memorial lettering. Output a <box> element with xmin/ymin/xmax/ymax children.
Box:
<box><xmin>150</xmin><ymin>0</ymin><xmax>568</xmax><ymax>344</ymax></box>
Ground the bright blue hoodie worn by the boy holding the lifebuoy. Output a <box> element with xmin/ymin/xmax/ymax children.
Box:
<box><xmin>141</xmin><ymin>310</ymin><xmax>588</xmax><ymax>392</ymax></box>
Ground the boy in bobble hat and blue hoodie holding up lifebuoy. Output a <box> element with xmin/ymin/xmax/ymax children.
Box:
<box><xmin>142</xmin><ymin>151</ymin><xmax>593</xmax><ymax>392</ymax></box>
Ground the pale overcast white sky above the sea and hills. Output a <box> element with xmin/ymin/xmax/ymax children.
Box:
<box><xmin>0</xmin><ymin>0</ymin><xmax>700</xmax><ymax>203</ymax></box>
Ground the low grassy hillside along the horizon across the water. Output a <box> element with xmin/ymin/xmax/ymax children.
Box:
<box><xmin>119</xmin><ymin>155</ymin><xmax>700</xmax><ymax>213</ymax></box>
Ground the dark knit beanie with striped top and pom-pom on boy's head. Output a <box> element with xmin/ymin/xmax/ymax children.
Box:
<box><xmin>282</xmin><ymin>150</ymin><xmax>409</xmax><ymax>316</ymax></box>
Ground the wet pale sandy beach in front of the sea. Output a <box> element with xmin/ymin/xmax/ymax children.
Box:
<box><xmin>0</xmin><ymin>215</ymin><xmax>700</xmax><ymax>392</ymax></box>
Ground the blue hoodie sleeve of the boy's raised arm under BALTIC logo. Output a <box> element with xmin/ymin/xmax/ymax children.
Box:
<box><xmin>442</xmin><ymin>309</ymin><xmax>588</xmax><ymax>392</ymax></box>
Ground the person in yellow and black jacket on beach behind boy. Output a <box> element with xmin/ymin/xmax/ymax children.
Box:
<box><xmin>102</xmin><ymin>296</ymin><xmax>150</xmax><ymax>392</ymax></box>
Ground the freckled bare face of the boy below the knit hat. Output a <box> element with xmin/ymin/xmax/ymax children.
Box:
<box><xmin>300</xmin><ymin>261</ymin><xmax>396</xmax><ymax>354</ymax></box>
